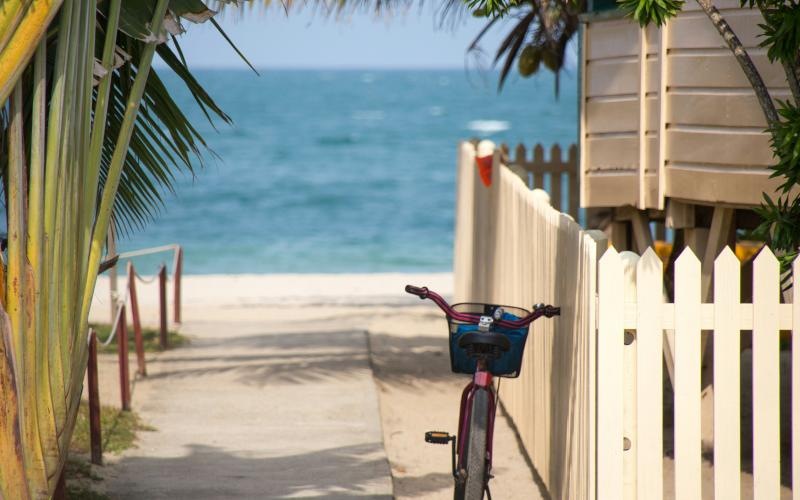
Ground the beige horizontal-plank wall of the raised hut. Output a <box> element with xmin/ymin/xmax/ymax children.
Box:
<box><xmin>581</xmin><ymin>9</ymin><xmax>789</xmax><ymax>208</ymax></box>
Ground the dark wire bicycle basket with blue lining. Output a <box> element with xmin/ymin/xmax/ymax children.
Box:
<box><xmin>447</xmin><ymin>303</ymin><xmax>529</xmax><ymax>378</ymax></box>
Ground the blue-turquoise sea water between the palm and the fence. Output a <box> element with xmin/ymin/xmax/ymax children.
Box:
<box><xmin>119</xmin><ymin>70</ymin><xmax>577</xmax><ymax>274</ymax></box>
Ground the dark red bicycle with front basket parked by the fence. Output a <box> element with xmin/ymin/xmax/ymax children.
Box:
<box><xmin>406</xmin><ymin>285</ymin><xmax>561</xmax><ymax>500</ymax></box>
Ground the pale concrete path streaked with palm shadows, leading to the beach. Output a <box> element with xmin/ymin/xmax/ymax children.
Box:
<box><xmin>105</xmin><ymin>306</ymin><xmax>392</xmax><ymax>499</ymax></box>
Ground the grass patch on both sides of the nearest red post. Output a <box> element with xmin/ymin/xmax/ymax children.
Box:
<box><xmin>69</xmin><ymin>401</ymin><xmax>155</xmax><ymax>454</ymax></box>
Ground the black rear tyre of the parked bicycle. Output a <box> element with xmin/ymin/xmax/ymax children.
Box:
<box><xmin>455</xmin><ymin>389</ymin><xmax>489</xmax><ymax>500</ymax></box>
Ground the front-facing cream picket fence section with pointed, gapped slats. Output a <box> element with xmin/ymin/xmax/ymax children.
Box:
<box><xmin>597</xmin><ymin>248</ymin><xmax>800</xmax><ymax>500</ymax></box>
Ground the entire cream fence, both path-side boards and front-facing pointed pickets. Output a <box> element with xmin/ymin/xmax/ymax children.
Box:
<box><xmin>454</xmin><ymin>143</ymin><xmax>800</xmax><ymax>500</ymax></box>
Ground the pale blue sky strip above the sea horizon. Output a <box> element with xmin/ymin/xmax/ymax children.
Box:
<box><xmin>160</xmin><ymin>6</ymin><xmax>508</xmax><ymax>69</ymax></box>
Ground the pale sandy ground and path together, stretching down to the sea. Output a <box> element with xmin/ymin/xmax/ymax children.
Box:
<box><xmin>92</xmin><ymin>273</ymin><xmax>540</xmax><ymax>499</ymax></box>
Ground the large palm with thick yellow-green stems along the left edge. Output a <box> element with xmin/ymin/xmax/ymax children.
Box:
<box><xmin>0</xmin><ymin>0</ymin><xmax>227</xmax><ymax>499</ymax></box>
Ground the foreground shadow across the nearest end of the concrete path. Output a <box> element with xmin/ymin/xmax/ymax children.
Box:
<box><xmin>106</xmin><ymin>443</ymin><xmax>392</xmax><ymax>500</ymax></box>
